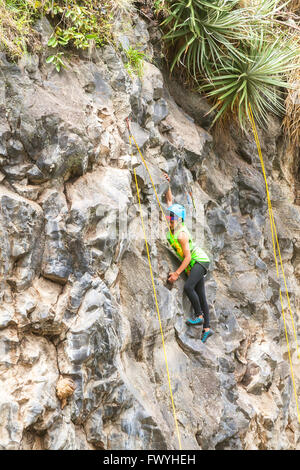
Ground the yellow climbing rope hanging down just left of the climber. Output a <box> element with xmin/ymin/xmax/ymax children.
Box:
<box><xmin>128</xmin><ymin>126</ymin><xmax>182</xmax><ymax>450</ymax></box>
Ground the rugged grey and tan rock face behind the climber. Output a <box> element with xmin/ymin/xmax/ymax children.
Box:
<box><xmin>0</xmin><ymin>12</ymin><xmax>300</xmax><ymax>450</ymax></box>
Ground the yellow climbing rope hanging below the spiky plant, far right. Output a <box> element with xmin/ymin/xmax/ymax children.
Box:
<box><xmin>249</xmin><ymin>103</ymin><xmax>300</xmax><ymax>424</ymax></box>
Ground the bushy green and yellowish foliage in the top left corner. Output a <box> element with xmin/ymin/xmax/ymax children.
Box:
<box><xmin>0</xmin><ymin>0</ymin><xmax>122</xmax><ymax>70</ymax></box>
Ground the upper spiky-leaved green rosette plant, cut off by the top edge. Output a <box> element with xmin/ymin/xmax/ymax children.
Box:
<box><xmin>162</xmin><ymin>0</ymin><xmax>249</xmax><ymax>78</ymax></box>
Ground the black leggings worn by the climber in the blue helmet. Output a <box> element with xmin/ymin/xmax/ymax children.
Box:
<box><xmin>184</xmin><ymin>263</ymin><xmax>209</xmax><ymax>328</ymax></box>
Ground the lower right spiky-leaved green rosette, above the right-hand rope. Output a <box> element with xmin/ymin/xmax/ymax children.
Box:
<box><xmin>200</xmin><ymin>35</ymin><xmax>297</xmax><ymax>128</ymax></box>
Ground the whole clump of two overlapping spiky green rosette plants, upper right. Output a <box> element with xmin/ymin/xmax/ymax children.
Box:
<box><xmin>162</xmin><ymin>0</ymin><xmax>299</xmax><ymax>128</ymax></box>
